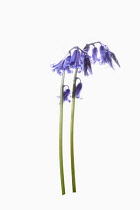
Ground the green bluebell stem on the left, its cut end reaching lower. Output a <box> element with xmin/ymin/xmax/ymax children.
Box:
<box><xmin>59</xmin><ymin>73</ymin><xmax>65</xmax><ymax>195</ymax></box>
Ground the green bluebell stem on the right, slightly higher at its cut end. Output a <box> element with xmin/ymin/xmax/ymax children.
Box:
<box><xmin>70</xmin><ymin>69</ymin><xmax>78</xmax><ymax>192</ymax></box>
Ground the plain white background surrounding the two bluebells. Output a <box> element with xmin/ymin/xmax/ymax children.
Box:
<box><xmin>0</xmin><ymin>0</ymin><xmax>140</xmax><ymax>210</ymax></box>
